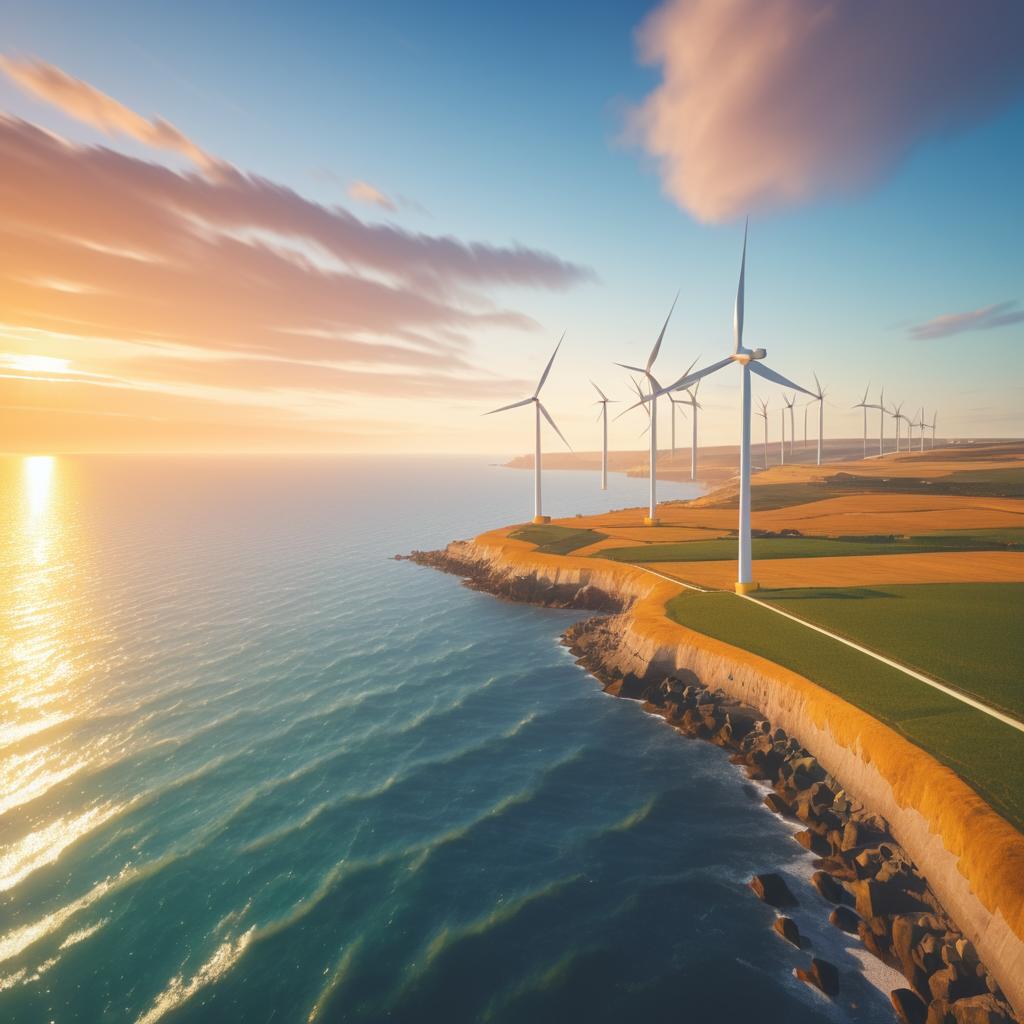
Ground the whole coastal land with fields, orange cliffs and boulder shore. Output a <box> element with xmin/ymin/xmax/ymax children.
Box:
<box><xmin>413</xmin><ymin>442</ymin><xmax>1024</xmax><ymax>1022</ymax></box>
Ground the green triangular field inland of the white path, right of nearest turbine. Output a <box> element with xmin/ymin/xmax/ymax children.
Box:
<box><xmin>758</xmin><ymin>583</ymin><xmax>1024</xmax><ymax>719</ymax></box>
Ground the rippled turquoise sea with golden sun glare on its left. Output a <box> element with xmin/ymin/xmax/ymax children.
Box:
<box><xmin>0</xmin><ymin>458</ymin><xmax>891</xmax><ymax>1024</ymax></box>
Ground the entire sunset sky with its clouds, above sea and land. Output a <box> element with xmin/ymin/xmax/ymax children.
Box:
<box><xmin>0</xmin><ymin>0</ymin><xmax>1024</xmax><ymax>454</ymax></box>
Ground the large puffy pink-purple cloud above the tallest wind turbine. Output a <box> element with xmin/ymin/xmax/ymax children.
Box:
<box><xmin>630</xmin><ymin>0</ymin><xmax>1024</xmax><ymax>222</ymax></box>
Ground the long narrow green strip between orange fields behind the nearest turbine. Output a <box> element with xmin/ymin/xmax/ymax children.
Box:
<box><xmin>598</xmin><ymin>527</ymin><xmax>1011</xmax><ymax>562</ymax></box>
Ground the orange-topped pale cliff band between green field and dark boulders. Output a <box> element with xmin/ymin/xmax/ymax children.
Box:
<box><xmin>421</xmin><ymin>531</ymin><xmax>1024</xmax><ymax>1016</ymax></box>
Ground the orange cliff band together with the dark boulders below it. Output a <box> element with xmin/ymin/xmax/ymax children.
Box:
<box><xmin>411</xmin><ymin>527</ymin><xmax>1024</xmax><ymax>1022</ymax></box>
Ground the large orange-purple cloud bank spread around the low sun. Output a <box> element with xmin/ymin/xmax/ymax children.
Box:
<box><xmin>0</xmin><ymin>105</ymin><xmax>593</xmax><ymax>450</ymax></box>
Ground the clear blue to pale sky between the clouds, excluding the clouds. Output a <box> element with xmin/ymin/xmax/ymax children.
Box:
<box><xmin>0</xmin><ymin>2</ymin><xmax>1024</xmax><ymax>452</ymax></box>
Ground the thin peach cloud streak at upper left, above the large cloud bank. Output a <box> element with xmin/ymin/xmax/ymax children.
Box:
<box><xmin>0</xmin><ymin>55</ymin><xmax>226</xmax><ymax>171</ymax></box>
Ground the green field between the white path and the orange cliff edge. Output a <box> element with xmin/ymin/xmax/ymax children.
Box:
<box><xmin>667</xmin><ymin>584</ymin><xmax>1024</xmax><ymax>828</ymax></box>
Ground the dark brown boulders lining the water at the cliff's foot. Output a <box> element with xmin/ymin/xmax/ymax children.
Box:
<box><xmin>409</xmin><ymin>543</ymin><xmax>1018</xmax><ymax>1024</ymax></box>
